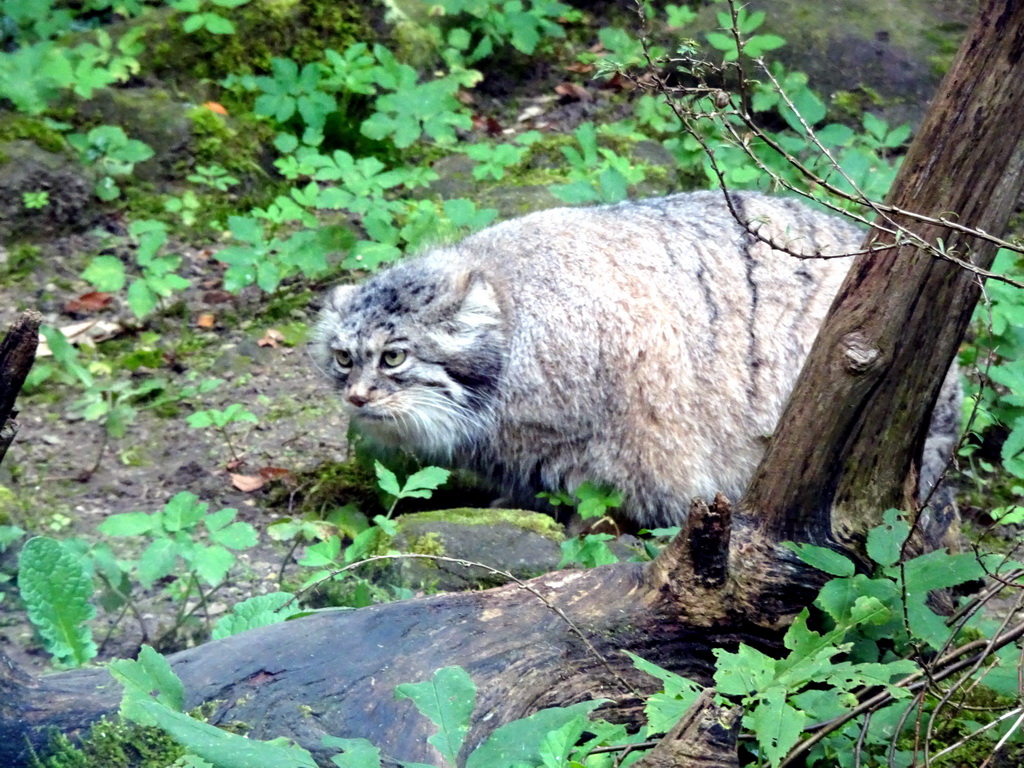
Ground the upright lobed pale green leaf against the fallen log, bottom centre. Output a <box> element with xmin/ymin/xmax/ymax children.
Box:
<box><xmin>394</xmin><ymin>667</ymin><xmax>476</xmax><ymax>766</ymax></box>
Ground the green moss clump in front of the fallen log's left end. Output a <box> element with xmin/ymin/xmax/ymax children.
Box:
<box><xmin>30</xmin><ymin>718</ymin><xmax>185</xmax><ymax>768</ymax></box>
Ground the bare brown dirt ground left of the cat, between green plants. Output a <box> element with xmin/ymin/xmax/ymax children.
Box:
<box><xmin>0</xmin><ymin>230</ymin><xmax>360</xmax><ymax>669</ymax></box>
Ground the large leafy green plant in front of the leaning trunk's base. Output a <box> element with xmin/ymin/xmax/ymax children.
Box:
<box><xmin>634</xmin><ymin>510</ymin><xmax>995</xmax><ymax>766</ymax></box>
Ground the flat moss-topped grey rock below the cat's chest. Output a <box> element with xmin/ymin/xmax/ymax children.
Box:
<box><xmin>381</xmin><ymin>509</ymin><xmax>564</xmax><ymax>591</ymax></box>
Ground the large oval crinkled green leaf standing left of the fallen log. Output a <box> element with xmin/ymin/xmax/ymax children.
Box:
<box><xmin>17</xmin><ymin>537</ymin><xmax>96</xmax><ymax>667</ymax></box>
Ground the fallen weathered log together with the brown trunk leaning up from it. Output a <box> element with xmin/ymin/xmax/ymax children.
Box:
<box><xmin>0</xmin><ymin>0</ymin><xmax>1024</xmax><ymax>768</ymax></box>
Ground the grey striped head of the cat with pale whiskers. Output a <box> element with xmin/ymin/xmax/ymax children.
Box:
<box><xmin>313</xmin><ymin>259</ymin><xmax>506</xmax><ymax>459</ymax></box>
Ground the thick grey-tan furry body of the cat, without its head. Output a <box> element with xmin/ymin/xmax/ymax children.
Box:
<box><xmin>440</xmin><ymin>191</ymin><xmax>861</xmax><ymax>519</ymax></box>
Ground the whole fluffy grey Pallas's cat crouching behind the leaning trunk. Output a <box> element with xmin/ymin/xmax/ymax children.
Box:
<box><xmin>313</xmin><ymin>191</ymin><xmax>958</xmax><ymax>527</ymax></box>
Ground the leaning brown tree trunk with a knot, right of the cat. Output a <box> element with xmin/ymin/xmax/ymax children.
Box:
<box><xmin>742</xmin><ymin>0</ymin><xmax>1024</xmax><ymax>551</ymax></box>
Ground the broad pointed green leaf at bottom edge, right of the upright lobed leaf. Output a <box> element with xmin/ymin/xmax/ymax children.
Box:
<box><xmin>466</xmin><ymin>698</ymin><xmax>607</xmax><ymax>768</ymax></box>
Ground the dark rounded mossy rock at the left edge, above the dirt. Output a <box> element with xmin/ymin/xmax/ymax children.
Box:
<box><xmin>0</xmin><ymin>139</ymin><xmax>99</xmax><ymax>242</ymax></box>
